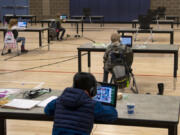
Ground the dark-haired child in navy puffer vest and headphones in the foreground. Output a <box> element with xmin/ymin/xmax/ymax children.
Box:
<box><xmin>44</xmin><ymin>72</ymin><xmax>117</xmax><ymax>135</ymax></box>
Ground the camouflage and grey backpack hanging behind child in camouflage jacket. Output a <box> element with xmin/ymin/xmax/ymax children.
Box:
<box><xmin>108</xmin><ymin>45</ymin><xmax>133</xmax><ymax>88</ymax></box>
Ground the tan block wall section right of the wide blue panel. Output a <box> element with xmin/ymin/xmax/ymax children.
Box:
<box><xmin>151</xmin><ymin>0</ymin><xmax>180</xmax><ymax>16</ymax></box>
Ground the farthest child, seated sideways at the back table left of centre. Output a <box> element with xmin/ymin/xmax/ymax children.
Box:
<box><xmin>53</xmin><ymin>14</ymin><xmax>66</xmax><ymax>40</ymax></box>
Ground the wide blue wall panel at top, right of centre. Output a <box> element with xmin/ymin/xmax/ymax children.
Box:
<box><xmin>70</xmin><ymin>0</ymin><xmax>150</xmax><ymax>22</ymax></box>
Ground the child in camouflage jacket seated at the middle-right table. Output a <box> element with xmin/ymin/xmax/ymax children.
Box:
<box><xmin>103</xmin><ymin>33</ymin><xmax>133</xmax><ymax>82</ymax></box>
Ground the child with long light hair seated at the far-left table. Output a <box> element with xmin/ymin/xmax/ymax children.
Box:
<box><xmin>8</xmin><ymin>19</ymin><xmax>28</xmax><ymax>53</ymax></box>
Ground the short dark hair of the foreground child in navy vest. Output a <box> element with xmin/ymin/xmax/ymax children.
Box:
<box><xmin>73</xmin><ymin>72</ymin><xmax>97</xmax><ymax>95</ymax></box>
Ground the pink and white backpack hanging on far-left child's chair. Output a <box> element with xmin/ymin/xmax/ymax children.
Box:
<box><xmin>4</xmin><ymin>31</ymin><xmax>16</xmax><ymax>49</ymax></box>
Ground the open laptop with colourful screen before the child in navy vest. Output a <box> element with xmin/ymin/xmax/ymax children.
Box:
<box><xmin>93</xmin><ymin>82</ymin><xmax>118</xmax><ymax>107</ymax></box>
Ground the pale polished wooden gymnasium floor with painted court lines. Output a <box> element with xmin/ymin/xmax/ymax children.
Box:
<box><xmin>0</xmin><ymin>24</ymin><xmax>180</xmax><ymax>135</ymax></box>
